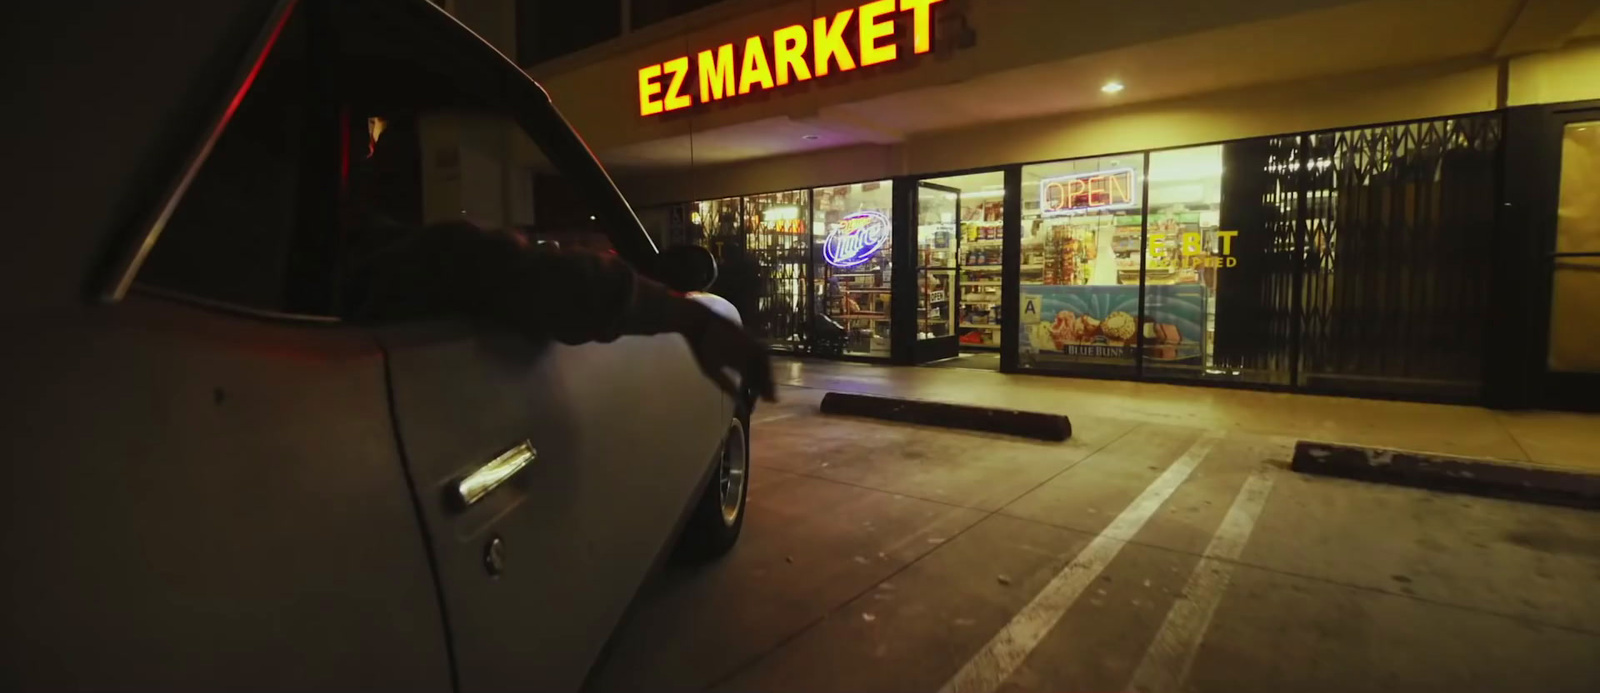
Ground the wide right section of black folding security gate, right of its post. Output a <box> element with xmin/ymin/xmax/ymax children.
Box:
<box><xmin>1296</xmin><ymin>115</ymin><xmax>1501</xmax><ymax>400</ymax></box>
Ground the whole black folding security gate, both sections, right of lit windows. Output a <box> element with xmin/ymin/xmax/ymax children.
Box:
<box><xmin>1216</xmin><ymin>114</ymin><xmax>1502</xmax><ymax>400</ymax></box>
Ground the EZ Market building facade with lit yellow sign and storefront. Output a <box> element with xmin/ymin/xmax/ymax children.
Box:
<box><xmin>469</xmin><ymin>0</ymin><xmax>1600</xmax><ymax>408</ymax></box>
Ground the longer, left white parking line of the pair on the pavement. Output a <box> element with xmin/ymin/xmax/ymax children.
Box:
<box><xmin>939</xmin><ymin>432</ymin><xmax>1221</xmax><ymax>693</ymax></box>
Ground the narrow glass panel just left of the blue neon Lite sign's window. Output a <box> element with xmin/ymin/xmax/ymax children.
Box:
<box><xmin>739</xmin><ymin>190</ymin><xmax>811</xmax><ymax>351</ymax></box>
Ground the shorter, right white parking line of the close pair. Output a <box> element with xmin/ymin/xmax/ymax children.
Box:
<box><xmin>1128</xmin><ymin>469</ymin><xmax>1272</xmax><ymax>693</ymax></box>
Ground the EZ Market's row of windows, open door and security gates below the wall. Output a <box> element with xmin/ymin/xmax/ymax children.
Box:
<box><xmin>640</xmin><ymin>112</ymin><xmax>1561</xmax><ymax>402</ymax></box>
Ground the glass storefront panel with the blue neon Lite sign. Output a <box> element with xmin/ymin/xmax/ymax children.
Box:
<box><xmin>811</xmin><ymin>181</ymin><xmax>894</xmax><ymax>359</ymax></box>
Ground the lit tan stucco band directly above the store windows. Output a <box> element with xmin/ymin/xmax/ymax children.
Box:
<box><xmin>618</xmin><ymin>61</ymin><xmax>1498</xmax><ymax>205</ymax></box>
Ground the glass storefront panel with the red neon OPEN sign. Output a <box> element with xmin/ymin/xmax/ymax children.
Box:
<box><xmin>1018</xmin><ymin>154</ymin><xmax>1144</xmax><ymax>375</ymax></box>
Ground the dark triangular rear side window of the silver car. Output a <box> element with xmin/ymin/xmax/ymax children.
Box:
<box><xmin>136</xmin><ymin>9</ymin><xmax>331</xmax><ymax>312</ymax></box>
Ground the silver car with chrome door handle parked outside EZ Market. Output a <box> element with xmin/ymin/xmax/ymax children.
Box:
<box><xmin>0</xmin><ymin>0</ymin><xmax>752</xmax><ymax>691</ymax></box>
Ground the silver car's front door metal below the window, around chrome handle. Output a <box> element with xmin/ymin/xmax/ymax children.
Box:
<box><xmin>379</xmin><ymin>323</ymin><xmax>726</xmax><ymax>693</ymax></box>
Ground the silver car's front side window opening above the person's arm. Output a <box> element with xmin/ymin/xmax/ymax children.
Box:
<box><xmin>339</xmin><ymin>62</ymin><xmax>611</xmax><ymax>320</ymax></box>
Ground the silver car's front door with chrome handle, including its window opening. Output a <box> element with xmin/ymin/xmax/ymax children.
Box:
<box><xmin>344</xmin><ymin>5</ymin><xmax>733</xmax><ymax>684</ymax></box>
